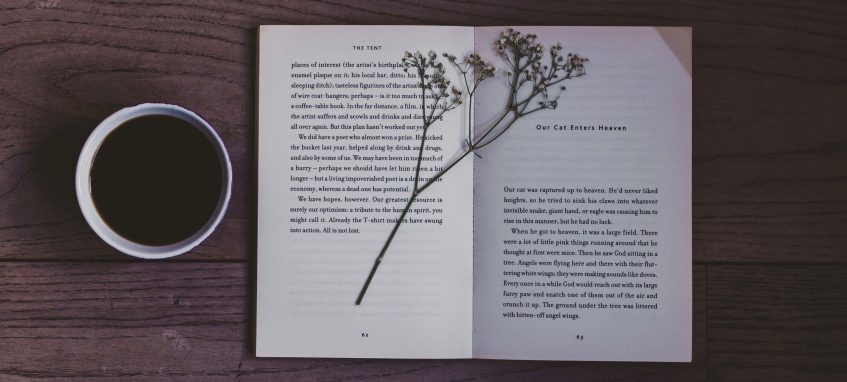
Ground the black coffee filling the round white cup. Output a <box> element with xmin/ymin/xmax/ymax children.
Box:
<box><xmin>91</xmin><ymin>116</ymin><xmax>223</xmax><ymax>246</ymax></box>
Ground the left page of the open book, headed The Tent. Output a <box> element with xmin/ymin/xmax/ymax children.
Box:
<box><xmin>256</xmin><ymin>26</ymin><xmax>474</xmax><ymax>358</ymax></box>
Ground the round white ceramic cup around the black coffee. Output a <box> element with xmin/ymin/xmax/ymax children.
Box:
<box><xmin>75</xmin><ymin>103</ymin><xmax>232</xmax><ymax>259</ymax></box>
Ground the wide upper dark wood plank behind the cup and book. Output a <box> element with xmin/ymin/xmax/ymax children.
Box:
<box><xmin>0</xmin><ymin>0</ymin><xmax>847</xmax><ymax>262</ymax></box>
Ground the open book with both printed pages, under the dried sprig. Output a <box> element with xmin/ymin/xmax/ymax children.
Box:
<box><xmin>256</xmin><ymin>26</ymin><xmax>692</xmax><ymax>362</ymax></box>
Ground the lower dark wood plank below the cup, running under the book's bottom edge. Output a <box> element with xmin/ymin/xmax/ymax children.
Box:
<box><xmin>0</xmin><ymin>262</ymin><xmax>706</xmax><ymax>382</ymax></box>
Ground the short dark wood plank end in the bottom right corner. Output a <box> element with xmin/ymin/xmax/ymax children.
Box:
<box><xmin>706</xmin><ymin>264</ymin><xmax>847</xmax><ymax>381</ymax></box>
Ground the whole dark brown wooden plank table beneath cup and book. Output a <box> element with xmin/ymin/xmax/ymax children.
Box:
<box><xmin>0</xmin><ymin>0</ymin><xmax>847</xmax><ymax>381</ymax></box>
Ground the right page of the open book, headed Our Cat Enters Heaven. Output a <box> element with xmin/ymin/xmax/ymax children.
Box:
<box><xmin>473</xmin><ymin>27</ymin><xmax>692</xmax><ymax>362</ymax></box>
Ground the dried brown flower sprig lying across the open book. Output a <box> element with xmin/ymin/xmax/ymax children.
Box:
<box><xmin>356</xmin><ymin>28</ymin><xmax>588</xmax><ymax>305</ymax></box>
